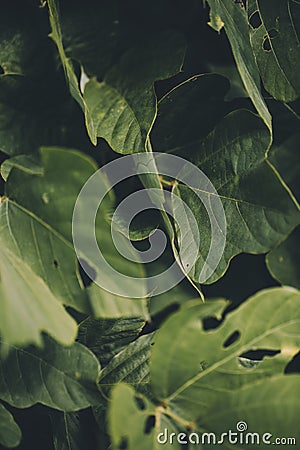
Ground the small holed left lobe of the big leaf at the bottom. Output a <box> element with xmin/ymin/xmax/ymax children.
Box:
<box><xmin>108</xmin><ymin>383</ymin><xmax>181</xmax><ymax>450</ymax></box>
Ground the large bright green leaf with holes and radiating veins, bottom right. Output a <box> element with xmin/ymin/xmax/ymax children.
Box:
<box><xmin>108</xmin><ymin>288</ymin><xmax>300</xmax><ymax>450</ymax></box>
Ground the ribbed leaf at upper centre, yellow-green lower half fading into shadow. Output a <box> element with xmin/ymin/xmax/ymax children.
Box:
<box><xmin>84</xmin><ymin>32</ymin><xmax>185</xmax><ymax>153</ymax></box>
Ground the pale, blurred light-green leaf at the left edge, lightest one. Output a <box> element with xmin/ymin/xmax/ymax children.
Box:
<box><xmin>0</xmin><ymin>237</ymin><xmax>77</xmax><ymax>346</ymax></box>
